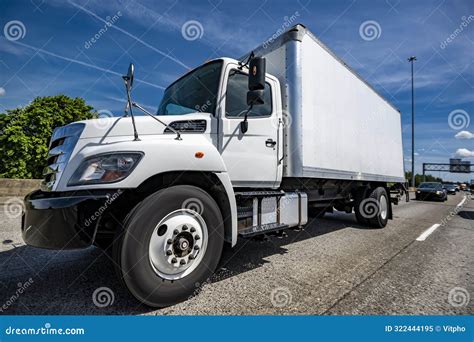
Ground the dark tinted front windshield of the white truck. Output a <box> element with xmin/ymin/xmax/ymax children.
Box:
<box><xmin>156</xmin><ymin>61</ymin><xmax>222</xmax><ymax>115</ymax></box>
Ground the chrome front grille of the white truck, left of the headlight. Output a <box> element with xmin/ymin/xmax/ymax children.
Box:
<box><xmin>41</xmin><ymin>123</ymin><xmax>85</xmax><ymax>191</ymax></box>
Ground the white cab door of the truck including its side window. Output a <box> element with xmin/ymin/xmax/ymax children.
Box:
<box><xmin>219</xmin><ymin>63</ymin><xmax>282</xmax><ymax>188</ymax></box>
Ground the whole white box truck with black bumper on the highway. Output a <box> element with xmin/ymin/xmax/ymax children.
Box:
<box><xmin>22</xmin><ymin>25</ymin><xmax>406</xmax><ymax>307</ymax></box>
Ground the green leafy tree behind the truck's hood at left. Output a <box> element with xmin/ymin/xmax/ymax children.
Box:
<box><xmin>0</xmin><ymin>95</ymin><xmax>97</xmax><ymax>178</ymax></box>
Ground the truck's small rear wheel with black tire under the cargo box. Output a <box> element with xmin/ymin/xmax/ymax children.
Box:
<box><xmin>361</xmin><ymin>187</ymin><xmax>390</xmax><ymax>228</ymax></box>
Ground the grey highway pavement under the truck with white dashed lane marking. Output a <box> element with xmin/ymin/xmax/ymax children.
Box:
<box><xmin>0</xmin><ymin>194</ymin><xmax>474</xmax><ymax>315</ymax></box>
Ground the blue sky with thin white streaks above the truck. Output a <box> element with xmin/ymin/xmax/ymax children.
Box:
<box><xmin>0</xmin><ymin>0</ymin><xmax>474</xmax><ymax>180</ymax></box>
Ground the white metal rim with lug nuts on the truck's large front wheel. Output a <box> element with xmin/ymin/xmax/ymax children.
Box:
<box><xmin>148</xmin><ymin>209</ymin><xmax>208</xmax><ymax>280</ymax></box>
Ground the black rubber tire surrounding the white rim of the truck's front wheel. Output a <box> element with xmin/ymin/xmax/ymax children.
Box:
<box><xmin>113</xmin><ymin>185</ymin><xmax>224</xmax><ymax>307</ymax></box>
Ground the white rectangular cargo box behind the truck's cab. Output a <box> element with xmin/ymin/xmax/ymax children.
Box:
<box><xmin>248</xmin><ymin>25</ymin><xmax>405</xmax><ymax>182</ymax></box>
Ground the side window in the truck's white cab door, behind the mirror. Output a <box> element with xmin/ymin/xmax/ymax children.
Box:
<box><xmin>225</xmin><ymin>70</ymin><xmax>272</xmax><ymax>117</ymax></box>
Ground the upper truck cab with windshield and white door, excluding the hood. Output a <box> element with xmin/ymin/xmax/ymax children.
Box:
<box><xmin>157</xmin><ymin>58</ymin><xmax>282</xmax><ymax>188</ymax></box>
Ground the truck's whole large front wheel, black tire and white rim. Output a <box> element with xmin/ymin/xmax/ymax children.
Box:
<box><xmin>114</xmin><ymin>185</ymin><xmax>224</xmax><ymax>307</ymax></box>
